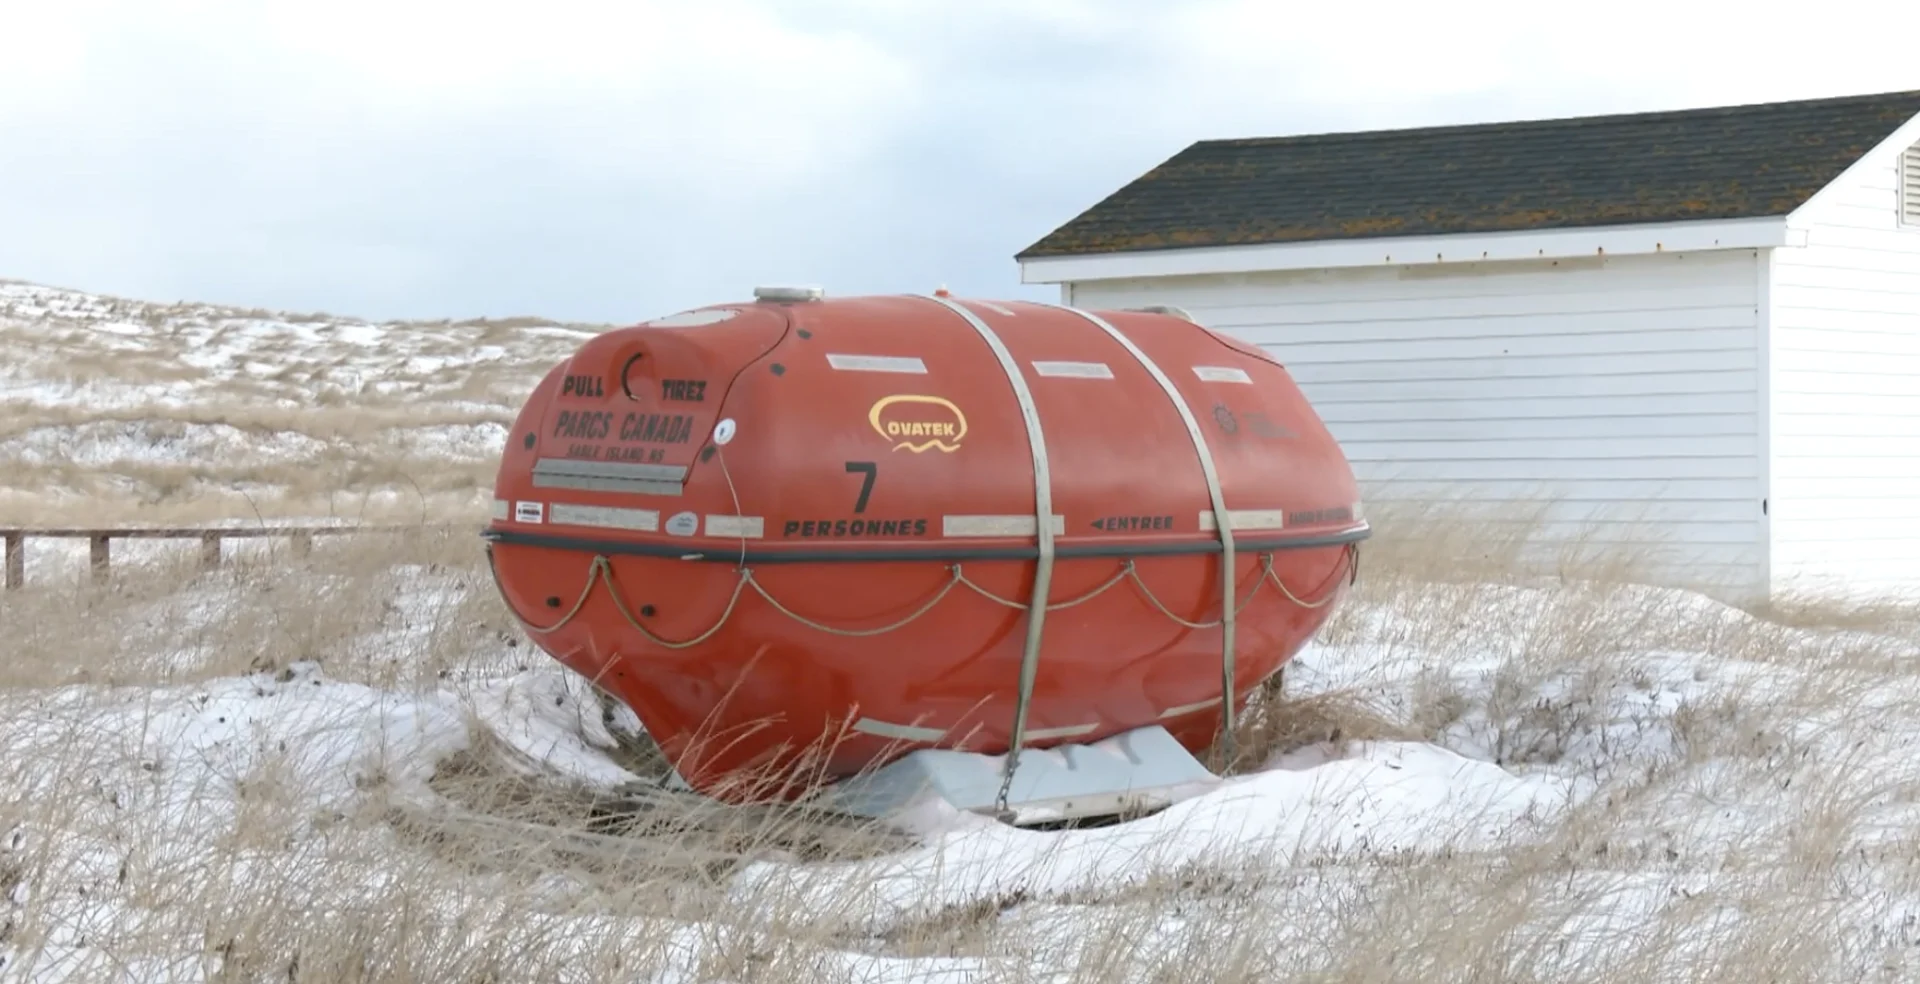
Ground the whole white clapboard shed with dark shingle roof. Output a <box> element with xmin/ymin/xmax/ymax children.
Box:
<box><xmin>1016</xmin><ymin>92</ymin><xmax>1920</xmax><ymax>602</ymax></box>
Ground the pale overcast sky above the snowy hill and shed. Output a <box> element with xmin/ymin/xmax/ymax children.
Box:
<box><xmin>0</xmin><ymin>0</ymin><xmax>1920</xmax><ymax>323</ymax></box>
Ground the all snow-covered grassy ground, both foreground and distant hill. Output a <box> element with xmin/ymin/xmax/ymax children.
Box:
<box><xmin>0</xmin><ymin>283</ymin><xmax>1920</xmax><ymax>984</ymax></box>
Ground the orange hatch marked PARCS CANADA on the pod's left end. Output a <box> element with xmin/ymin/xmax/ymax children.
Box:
<box><xmin>532</xmin><ymin>304</ymin><xmax>789</xmax><ymax>494</ymax></box>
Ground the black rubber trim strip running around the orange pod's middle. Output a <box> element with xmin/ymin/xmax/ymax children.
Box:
<box><xmin>480</xmin><ymin>527</ymin><xmax>1373</xmax><ymax>563</ymax></box>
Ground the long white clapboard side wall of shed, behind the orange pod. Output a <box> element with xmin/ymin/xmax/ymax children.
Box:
<box><xmin>1071</xmin><ymin>250</ymin><xmax>1764</xmax><ymax>590</ymax></box>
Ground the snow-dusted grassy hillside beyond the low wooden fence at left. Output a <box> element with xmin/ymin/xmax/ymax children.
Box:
<box><xmin>0</xmin><ymin>281</ymin><xmax>606</xmax><ymax>523</ymax></box>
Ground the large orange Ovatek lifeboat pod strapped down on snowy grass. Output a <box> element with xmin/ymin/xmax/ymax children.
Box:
<box><xmin>486</xmin><ymin>296</ymin><xmax>1369</xmax><ymax>807</ymax></box>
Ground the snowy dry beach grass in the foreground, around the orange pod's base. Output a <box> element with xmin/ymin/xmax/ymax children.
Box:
<box><xmin>0</xmin><ymin>503</ymin><xmax>1920</xmax><ymax>984</ymax></box>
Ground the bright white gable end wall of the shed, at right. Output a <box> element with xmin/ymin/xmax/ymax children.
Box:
<box><xmin>1768</xmin><ymin>141</ymin><xmax>1920</xmax><ymax>590</ymax></box>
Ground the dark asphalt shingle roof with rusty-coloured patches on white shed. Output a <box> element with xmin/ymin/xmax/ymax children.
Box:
<box><xmin>1016</xmin><ymin>90</ymin><xmax>1920</xmax><ymax>259</ymax></box>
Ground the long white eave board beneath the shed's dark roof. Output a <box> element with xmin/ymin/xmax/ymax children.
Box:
<box><xmin>1020</xmin><ymin>213</ymin><xmax>1789</xmax><ymax>284</ymax></box>
